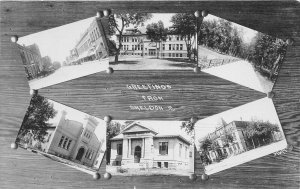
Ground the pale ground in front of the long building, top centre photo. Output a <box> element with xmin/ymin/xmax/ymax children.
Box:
<box><xmin>109</xmin><ymin>56</ymin><xmax>195</xmax><ymax>70</ymax></box>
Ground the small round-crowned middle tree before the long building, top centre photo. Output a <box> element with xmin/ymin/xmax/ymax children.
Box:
<box><xmin>146</xmin><ymin>20</ymin><xmax>168</xmax><ymax>58</ymax></box>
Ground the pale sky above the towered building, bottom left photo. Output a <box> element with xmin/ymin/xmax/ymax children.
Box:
<box><xmin>44</xmin><ymin>100</ymin><xmax>106</xmax><ymax>140</ymax></box>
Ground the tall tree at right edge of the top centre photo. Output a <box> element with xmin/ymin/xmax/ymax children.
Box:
<box><xmin>171</xmin><ymin>13</ymin><xmax>197</xmax><ymax>60</ymax></box>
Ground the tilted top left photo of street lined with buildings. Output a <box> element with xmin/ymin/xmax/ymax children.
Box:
<box><xmin>17</xmin><ymin>17</ymin><xmax>109</xmax><ymax>89</ymax></box>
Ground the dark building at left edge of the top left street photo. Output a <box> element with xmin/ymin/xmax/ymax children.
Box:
<box><xmin>17</xmin><ymin>44</ymin><xmax>43</xmax><ymax>79</ymax></box>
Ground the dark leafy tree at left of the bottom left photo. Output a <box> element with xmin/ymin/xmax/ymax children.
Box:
<box><xmin>19</xmin><ymin>95</ymin><xmax>57</xmax><ymax>143</ymax></box>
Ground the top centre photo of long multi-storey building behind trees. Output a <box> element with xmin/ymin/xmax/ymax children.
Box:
<box><xmin>108</xmin><ymin>12</ymin><xmax>197</xmax><ymax>70</ymax></box>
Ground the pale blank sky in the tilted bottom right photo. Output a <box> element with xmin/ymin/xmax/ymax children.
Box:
<box><xmin>195</xmin><ymin>97</ymin><xmax>280</xmax><ymax>141</ymax></box>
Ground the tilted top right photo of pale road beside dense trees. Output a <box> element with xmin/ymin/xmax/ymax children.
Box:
<box><xmin>198</xmin><ymin>14</ymin><xmax>287</xmax><ymax>93</ymax></box>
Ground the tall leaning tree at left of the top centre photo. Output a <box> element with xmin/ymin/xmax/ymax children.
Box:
<box><xmin>108</xmin><ymin>13</ymin><xmax>152</xmax><ymax>63</ymax></box>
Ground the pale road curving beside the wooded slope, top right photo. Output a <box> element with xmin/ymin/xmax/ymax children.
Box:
<box><xmin>203</xmin><ymin>60</ymin><xmax>274</xmax><ymax>93</ymax></box>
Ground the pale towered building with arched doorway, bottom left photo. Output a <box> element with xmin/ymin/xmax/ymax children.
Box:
<box><xmin>31</xmin><ymin>111</ymin><xmax>105</xmax><ymax>168</ymax></box>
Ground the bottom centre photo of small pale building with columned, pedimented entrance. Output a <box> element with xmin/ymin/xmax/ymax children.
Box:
<box><xmin>106</xmin><ymin>120</ymin><xmax>194</xmax><ymax>176</ymax></box>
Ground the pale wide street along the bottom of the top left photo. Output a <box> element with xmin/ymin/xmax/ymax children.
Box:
<box><xmin>28</xmin><ymin>58</ymin><xmax>109</xmax><ymax>89</ymax></box>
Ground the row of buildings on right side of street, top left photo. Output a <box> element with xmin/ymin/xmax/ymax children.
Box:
<box><xmin>66</xmin><ymin>18</ymin><xmax>108</xmax><ymax>64</ymax></box>
